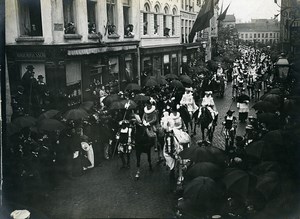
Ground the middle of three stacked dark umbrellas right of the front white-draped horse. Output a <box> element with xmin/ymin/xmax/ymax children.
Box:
<box><xmin>186</xmin><ymin>162</ymin><xmax>222</xmax><ymax>179</ymax></box>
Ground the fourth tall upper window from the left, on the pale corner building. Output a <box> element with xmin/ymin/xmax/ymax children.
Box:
<box><xmin>106</xmin><ymin>0</ymin><xmax>117</xmax><ymax>35</ymax></box>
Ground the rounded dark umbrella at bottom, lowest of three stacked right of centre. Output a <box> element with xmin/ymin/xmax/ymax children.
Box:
<box><xmin>183</xmin><ymin>176</ymin><xmax>222</xmax><ymax>209</ymax></box>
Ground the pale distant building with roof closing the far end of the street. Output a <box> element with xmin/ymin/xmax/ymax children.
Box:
<box><xmin>236</xmin><ymin>19</ymin><xmax>280</xmax><ymax>44</ymax></box>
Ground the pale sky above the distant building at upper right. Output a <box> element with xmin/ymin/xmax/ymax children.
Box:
<box><xmin>219</xmin><ymin>0</ymin><xmax>280</xmax><ymax>22</ymax></box>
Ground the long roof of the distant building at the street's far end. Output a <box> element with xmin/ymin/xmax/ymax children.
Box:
<box><xmin>235</xmin><ymin>22</ymin><xmax>280</xmax><ymax>32</ymax></box>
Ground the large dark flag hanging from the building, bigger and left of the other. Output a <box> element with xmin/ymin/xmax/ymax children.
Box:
<box><xmin>189</xmin><ymin>0</ymin><xmax>215</xmax><ymax>43</ymax></box>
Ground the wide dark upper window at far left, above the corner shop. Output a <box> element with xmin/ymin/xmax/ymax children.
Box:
<box><xmin>19</xmin><ymin>0</ymin><xmax>43</xmax><ymax>36</ymax></box>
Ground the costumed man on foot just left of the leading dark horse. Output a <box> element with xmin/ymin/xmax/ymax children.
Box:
<box><xmin>117</xmin><ymin>120</ymin><xmax>132</xmax><ymax>169</ymax></box>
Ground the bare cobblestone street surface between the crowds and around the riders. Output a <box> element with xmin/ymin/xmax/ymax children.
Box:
<box><xmin>29</xmin><ymin>85</ymin><xmax>253</xmax><ymax>218</ymax></box>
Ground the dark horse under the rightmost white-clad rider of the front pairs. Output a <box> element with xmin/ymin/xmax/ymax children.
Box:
<box><xmin>193</xmin><ymin>107</ymin><xmax>217</xmax><ymax>141</ymax></box>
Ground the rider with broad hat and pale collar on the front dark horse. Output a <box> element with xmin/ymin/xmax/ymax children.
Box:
<box><xmin>142</xmin><ymin>100</ymin><xmax>158</xmax><ymax>151</ymax></box>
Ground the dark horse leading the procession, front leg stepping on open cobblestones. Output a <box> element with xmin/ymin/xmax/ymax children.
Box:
<box><xmin>135</xmin><ymin>124</ymin><xmax>155</xmax><ymax>179</ymax></box>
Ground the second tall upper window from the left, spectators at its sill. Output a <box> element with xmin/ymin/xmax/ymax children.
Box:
<box><xmin>63</xmin><ymin>0</ymin><xmax>76</xmax><ymax>34</ymax></box>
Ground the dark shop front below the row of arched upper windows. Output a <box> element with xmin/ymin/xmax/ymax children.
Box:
<box><xmin>140</xmin><ymin>46</ymin><xmax>181</xmax><ymax>85</ymax></box>
